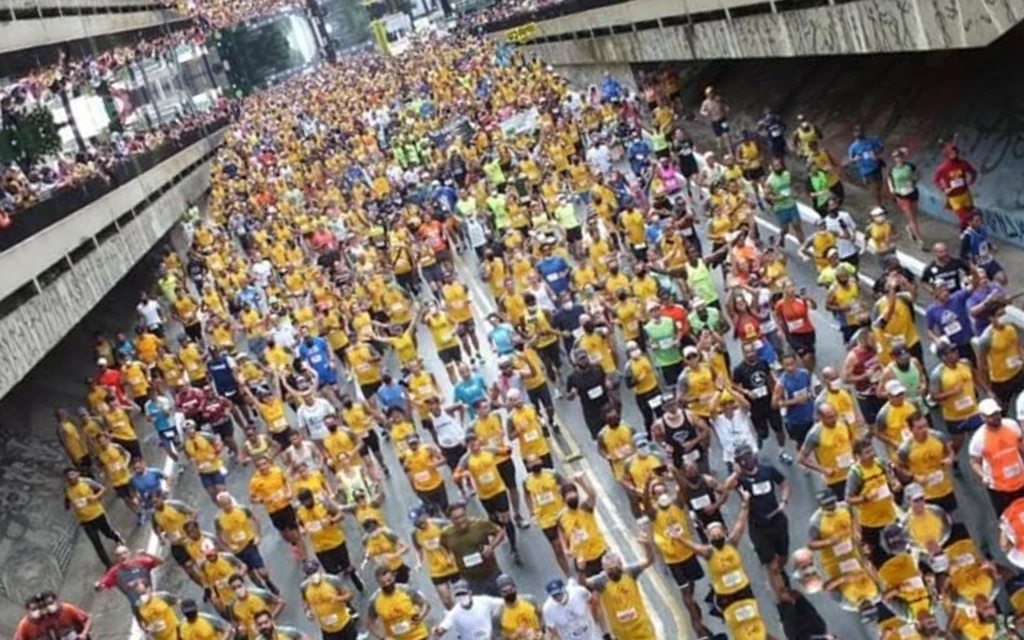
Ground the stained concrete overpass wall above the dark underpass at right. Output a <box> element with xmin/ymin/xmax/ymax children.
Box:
<box><xmin>512</xmin><ymin>0</ymin><xmax>1024</xmax><ymax>65</ymax></box>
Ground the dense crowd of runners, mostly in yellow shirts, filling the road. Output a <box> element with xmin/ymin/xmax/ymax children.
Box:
<box><xmin>12</xmin><ymin>29</ymin><xmax>1024</xmax><ymax>640</ymax></box>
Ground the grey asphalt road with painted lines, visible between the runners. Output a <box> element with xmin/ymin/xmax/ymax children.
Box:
<box><xmin>144</xmin><ymin>206</ymin><xmax>997</xmax><ymax>640</ymax></box>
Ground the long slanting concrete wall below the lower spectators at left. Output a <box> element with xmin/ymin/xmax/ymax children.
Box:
<box><xmin>0</xmin><ymin>134</ymin><xmax>221</xmax><ymax>397</ymax></box>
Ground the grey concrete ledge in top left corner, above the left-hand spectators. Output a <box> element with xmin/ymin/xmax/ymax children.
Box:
<box><xmin>0</xmin><ymin>10</ymin><xmax>181</xmax><ymax>53</ymax></box>
